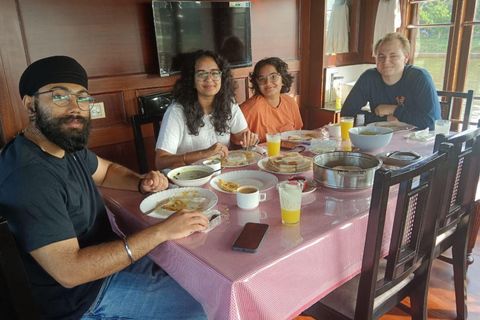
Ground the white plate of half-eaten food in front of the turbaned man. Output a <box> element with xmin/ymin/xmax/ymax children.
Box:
<box><xmin>140</xmin><ymin>187</ymin><xmax>218</xmax><ymax>219</ymax></box>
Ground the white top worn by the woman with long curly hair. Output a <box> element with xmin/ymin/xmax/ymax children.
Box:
<box><xmin>156</xmin><ymin>102</ymin><xmax>248</xmax><ymax>154</ymax></box>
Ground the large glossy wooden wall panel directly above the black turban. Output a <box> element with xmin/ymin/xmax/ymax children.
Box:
<box><xmin>18</xmin><ymin>0</ymin><xmax>158</xmax><ymax>77</ymax></box>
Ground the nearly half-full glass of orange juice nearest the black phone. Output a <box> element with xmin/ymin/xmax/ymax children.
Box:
<box><xmin>278</xmin><ymin>181</ymin><xmax>302</xmax><ymax>226</ymax></box>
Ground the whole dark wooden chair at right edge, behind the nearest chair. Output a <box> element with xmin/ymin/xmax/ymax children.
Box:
<box><xmin>434</xmin><ymin>123</ymin><xmax>480</xmax><ymax>319</ymax></box>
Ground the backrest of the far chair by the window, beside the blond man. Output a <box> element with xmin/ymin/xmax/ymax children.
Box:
<box><xmin>437</xmin><ymin>90</ymin><xmax>474</xmax><ymax>131</ymax></box>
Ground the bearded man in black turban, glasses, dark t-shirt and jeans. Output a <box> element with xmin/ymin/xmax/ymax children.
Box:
<box><xmin>0</xmin><ymin>56</ymin><xmax>209</xmax><ymax>319</ymax></box>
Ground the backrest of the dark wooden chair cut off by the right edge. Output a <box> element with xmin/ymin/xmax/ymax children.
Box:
<box><xmin>434</xmin><ymin>128</ymin><xmax>480</xmax><ymax>240</ymax></box>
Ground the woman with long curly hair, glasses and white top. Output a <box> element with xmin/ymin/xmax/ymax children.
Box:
<box><xmin>155</xmin><ymin>50</ymin><xmax>257</xmax><ymax>170</ymax></box>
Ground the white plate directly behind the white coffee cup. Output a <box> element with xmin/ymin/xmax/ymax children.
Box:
<box><xmin>210</xmin><ymin>170</ymin><xmax>278</xmax><ymax>194</ymax></box>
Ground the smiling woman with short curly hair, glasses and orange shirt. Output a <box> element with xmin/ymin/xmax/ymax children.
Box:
<box><xmin>240</xmin><ymin>57</ymin><xmax>303</xmax><ymax>142</ymax></box>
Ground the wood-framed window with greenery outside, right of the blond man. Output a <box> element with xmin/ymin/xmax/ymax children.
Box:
<box><xmin>407</xmin><ymin>0</ymin><xmax>480</xmax><ymax>123</ymax></box>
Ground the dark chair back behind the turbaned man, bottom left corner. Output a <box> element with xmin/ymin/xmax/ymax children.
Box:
<box><xmin>0</xmin><ymin>216</ymin><xmax>41</xmax><ymax>320</ymax></box>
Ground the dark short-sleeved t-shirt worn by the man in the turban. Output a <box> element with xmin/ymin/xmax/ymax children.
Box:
<box><xmin>0</xmin><ymin>135</ymin><xmax>116</xmax><ymax>319</ymax></box>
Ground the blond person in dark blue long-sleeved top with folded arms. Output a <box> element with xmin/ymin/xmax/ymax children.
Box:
<box><xmin>341</xmin><ymin>32</ymin><xmax>441</xmax><ymax>130</ymax></box>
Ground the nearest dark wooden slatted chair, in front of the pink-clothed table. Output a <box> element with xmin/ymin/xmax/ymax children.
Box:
<box><xmin>304</xmin><ymin>144</ymin><xmax>452</xmax><ymax>320</ymax></box>
